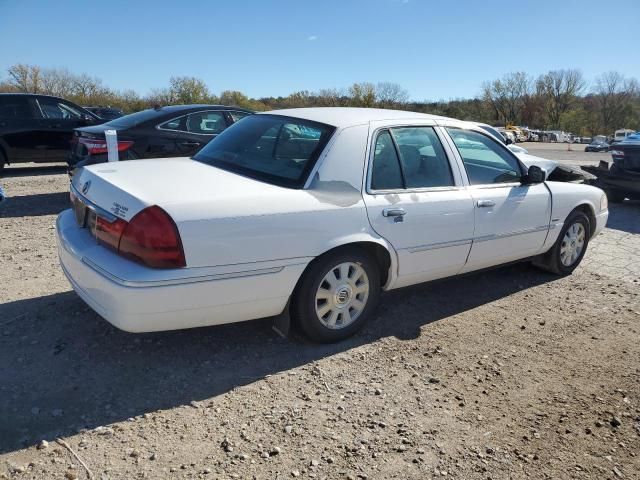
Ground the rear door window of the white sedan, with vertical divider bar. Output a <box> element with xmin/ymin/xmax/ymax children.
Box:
<box><xmin>371</xmin><ymin>127</ymin><xmax>455</xmax><ymax>190</ymax></box>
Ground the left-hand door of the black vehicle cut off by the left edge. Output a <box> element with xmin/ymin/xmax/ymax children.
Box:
<box><xmin>0</xmin><ymin>95</ymin><xmax>46</xmax><ymax>162</ymax></box>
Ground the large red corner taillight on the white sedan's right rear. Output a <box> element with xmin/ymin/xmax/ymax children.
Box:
<box><xmin>118</xmin><ymin>205</ymin><xmax>186</xmax><ymax>268</ymax></box>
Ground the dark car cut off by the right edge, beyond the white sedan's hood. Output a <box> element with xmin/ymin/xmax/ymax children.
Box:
<box><xmin>585</xmin><ymin>134</ymin><xmax>640</xmax><ymax>203</ymax></box>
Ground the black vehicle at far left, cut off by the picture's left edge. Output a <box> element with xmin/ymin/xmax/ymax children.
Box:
<box><xmin>0</xmin><ymin>93</ymin><xmax>101</xmax><ymax>170</ymax></box>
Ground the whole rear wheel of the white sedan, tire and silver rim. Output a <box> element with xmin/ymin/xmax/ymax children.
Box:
<box><xmin>291</xmin><ymin>248</ymin><xmax>380</xmax><ymax>343</ymax></box>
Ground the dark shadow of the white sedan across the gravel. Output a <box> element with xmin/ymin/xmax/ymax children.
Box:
<box><xmin>0</xmin><ymin>264</ymin><xmax>557</xmax><ymax>453</ymax></box>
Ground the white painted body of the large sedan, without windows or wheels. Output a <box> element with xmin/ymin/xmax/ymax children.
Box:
<box><xmin>57</xmin><ymin>108</ymin><xmax>607</xmax><ymax>332</ymax></box>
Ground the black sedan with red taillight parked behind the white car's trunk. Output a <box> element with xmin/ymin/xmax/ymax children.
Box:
<box><xmin>68</xmin><ymin>105</ymin><xmax>253</xmax><ymax>169</ymax></box>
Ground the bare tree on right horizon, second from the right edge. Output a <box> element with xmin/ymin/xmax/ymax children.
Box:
<box><xmin>537</xmin><ymin>69</ymin><xmax>586</xmax><ymax>128</ymax></box>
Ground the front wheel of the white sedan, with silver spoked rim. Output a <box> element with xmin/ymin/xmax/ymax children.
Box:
<box><xmin>534</xmin><ymin>211</ymin><xmax>591</xmax><ymax>275</ymax></box>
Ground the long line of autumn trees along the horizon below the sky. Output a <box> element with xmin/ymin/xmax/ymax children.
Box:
<box><xmin>0</xmin><ymin>64</ymin><xmax>640</xmax><ymax>136</ymax></box>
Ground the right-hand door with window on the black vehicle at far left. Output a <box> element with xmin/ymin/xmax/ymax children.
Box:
<box><xmin>36</xmin><ymin>97</ymin><xmax>90</xmax><ymax>162</ymax></box>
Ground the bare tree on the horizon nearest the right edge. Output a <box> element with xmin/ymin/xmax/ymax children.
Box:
<box><xmin>594</xmin><ymin>72</ymin><xmax>639</xmax><ymax>130</ymax></box>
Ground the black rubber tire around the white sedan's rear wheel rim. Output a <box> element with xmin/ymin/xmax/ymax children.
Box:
<box><xmin>291</xmin><ymin>247</ymin><xmax>380</xmax><ymax>343</ymax></box>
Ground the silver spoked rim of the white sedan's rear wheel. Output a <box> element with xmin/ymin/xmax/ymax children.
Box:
<box><xmin>315</xmin><ymin>262</ymin><xmax>369</xmax><ymax>330</ymax></box>
